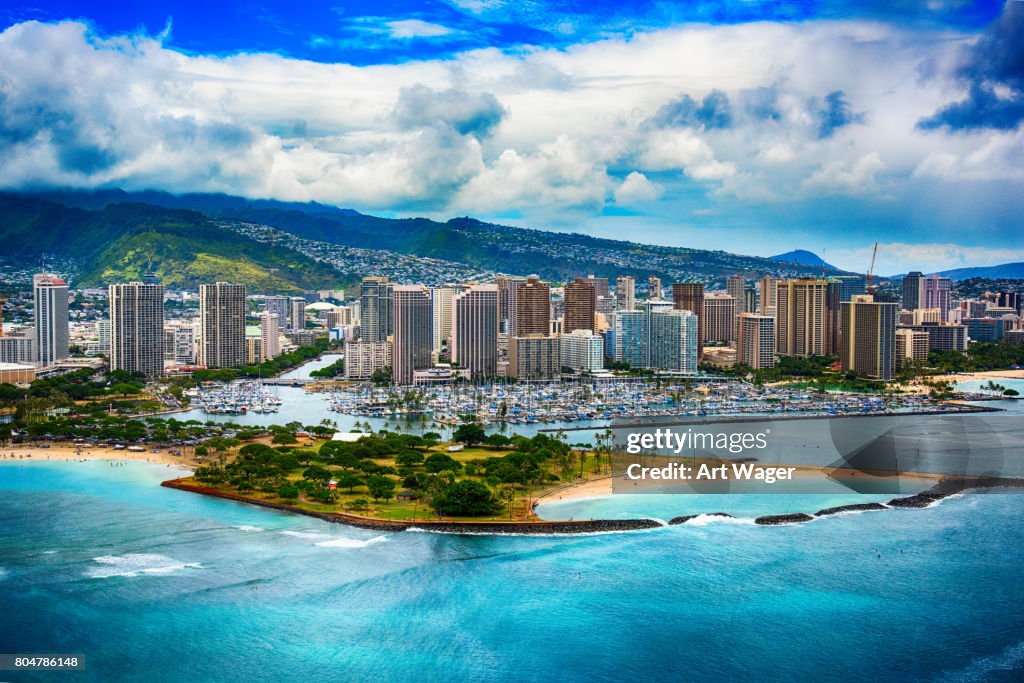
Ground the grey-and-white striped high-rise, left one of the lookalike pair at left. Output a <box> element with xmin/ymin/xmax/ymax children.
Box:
<box><xmin>110</xmin><ymin>283</ymin><xmax>164</xmax><ymax>379</ymax></box>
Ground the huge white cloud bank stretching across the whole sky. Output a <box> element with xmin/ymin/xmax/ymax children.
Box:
<box><xmin>0</xmin><ymin>11</ymin><xmax>1020</xmax><ymax>235</ymax></box>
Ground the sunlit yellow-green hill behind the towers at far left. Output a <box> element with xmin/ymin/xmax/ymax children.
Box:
<box><xmin>0</xmin><ymin>195</ymin><xmax>349</xmax><ymax>293</ymax></box>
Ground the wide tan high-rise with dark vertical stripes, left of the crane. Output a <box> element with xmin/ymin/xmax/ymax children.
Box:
<box><xmin>775</xmin><ymin>279</ymin><xmax>839</xmax><ymax>357</ymax></box>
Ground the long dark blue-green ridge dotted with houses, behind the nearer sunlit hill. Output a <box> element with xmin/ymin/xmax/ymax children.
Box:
<box><xmin>24</xmin><ymin>190</ymin><xmax>856</xmax><ymax>287</ymax></box>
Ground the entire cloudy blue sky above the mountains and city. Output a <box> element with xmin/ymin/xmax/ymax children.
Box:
<box><xmin>0</xmin><ymin>0</ymin><xmax>1024</xmax><ymax>272</ymax></box>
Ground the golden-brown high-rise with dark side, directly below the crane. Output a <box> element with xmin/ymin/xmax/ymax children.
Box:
<box><xmin>840</xmin><ymin>294</ymin><xmax>899</xmax><ymax>380</ymax></box>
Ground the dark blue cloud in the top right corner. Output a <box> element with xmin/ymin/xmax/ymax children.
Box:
<box><xmin>918</xmin><ymin>0</ymin><xmax>1024</xmax><ymax>130</ymax></box>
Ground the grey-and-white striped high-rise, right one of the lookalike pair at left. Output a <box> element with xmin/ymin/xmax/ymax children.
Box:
<box><xmin>199</xmin><ymin>283</ymin><xmax>247</xmax><ymax>368</ymax></box>
